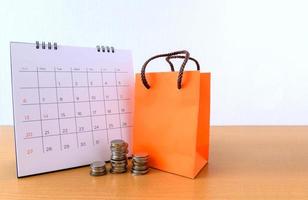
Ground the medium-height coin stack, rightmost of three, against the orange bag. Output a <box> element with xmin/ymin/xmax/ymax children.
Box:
<box><xmin>131</xmin><ymin>153</ymin><xmax>150</xmax><ymax>175</ymax></box>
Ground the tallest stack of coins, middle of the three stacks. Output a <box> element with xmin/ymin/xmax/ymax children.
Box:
<box><xmin>110</xmin><ymin>140</ymin><xmax>128</xmax><ymax>174</ymax></box>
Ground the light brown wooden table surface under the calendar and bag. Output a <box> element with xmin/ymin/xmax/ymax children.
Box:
<box><xmin>0</xmin><ymin>127</ymin><xmax>308</xmax><ymax>200</ymax></box>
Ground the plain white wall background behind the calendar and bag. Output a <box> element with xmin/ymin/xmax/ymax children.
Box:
<box><xmin>0</xmin><ymin>0</ymin><xmax>308</xmax><ymax>125</ymax></box>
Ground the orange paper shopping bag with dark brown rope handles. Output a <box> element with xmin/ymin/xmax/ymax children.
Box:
<box><xmin>133</xmin><ymin>51</ymin><xmax>210</xmax><ymax>178</ymax></box>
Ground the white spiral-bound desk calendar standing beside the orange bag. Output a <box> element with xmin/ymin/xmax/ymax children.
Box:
<box><xmin>10</xmin><ymin>42</ymin><xmax>134</xmax><ymax>177</ymax></box>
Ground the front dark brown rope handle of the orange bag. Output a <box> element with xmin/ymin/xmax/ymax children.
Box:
<box><xmin>141</xmin><ymin>50</ymin><xmax>189</xmax><ymax>89</ymax></box>
